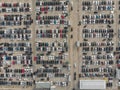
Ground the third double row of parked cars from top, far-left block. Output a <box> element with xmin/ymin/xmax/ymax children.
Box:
<box><xmin>0</xmin><ymin>28</ymin><xmax>32</xmax><ymax>40</ymax></box>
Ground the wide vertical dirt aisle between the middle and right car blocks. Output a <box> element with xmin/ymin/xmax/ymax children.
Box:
<box><xmin>70</xmin><ymin>0</ymin><xmax>79</xmax><ymax>90</ymax></box>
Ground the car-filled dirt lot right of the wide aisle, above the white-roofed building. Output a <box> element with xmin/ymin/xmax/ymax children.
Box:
<box><xmin>75</xmin><ymin>0</ymin><xmax>119</xmax><ymax>90</ymax></box>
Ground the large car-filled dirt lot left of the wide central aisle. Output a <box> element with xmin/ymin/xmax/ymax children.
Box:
<box><xmin>0</xmin><ymin>0</ymin><xmax>71</xmax><ymax>89</ymax></box>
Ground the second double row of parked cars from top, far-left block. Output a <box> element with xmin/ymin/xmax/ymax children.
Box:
<box><xmin>0</xmin><ymin>14</ymin><xmax>33</xmax><ymax>26</ymax></box>
